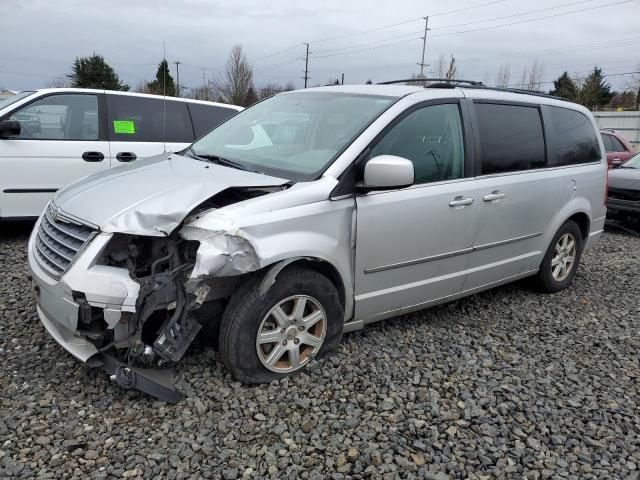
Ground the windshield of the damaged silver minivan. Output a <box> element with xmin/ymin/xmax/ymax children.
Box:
<box><xmin>190</xmin><ymin>92</ymin><xmax>396</xmax><ymax>181</ymax></box>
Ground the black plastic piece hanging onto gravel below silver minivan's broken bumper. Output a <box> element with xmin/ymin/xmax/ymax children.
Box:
<box><xmin>96</xmin><ymin>354</ymin><xmax>184</xmax><ymax>403</ymax></box>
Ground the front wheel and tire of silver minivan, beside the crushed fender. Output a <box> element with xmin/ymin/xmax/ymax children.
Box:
<box><xmin>219</xmin><ymin>268</ymin><xmax>344</xmax><ymax>383</ymax></box>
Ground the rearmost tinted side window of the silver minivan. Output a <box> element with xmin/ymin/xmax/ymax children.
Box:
<box><xmin>545</xmin><ymin>107</ymin><xmax>608</xmax><ymax>166</ymax></box>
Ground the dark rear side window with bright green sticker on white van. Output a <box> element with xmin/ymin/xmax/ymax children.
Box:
<box><xmin>107</xmin><ymin>95</ymin><xmax>193</xmax><ymax>143</ymax></box>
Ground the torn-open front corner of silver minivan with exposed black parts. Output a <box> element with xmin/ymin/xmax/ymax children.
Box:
<box><xmin>90</xmin><ymin>225</ymin><xmax>252</xmax><ymax>402</ymax></box>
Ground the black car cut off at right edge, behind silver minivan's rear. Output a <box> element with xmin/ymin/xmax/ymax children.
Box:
<box><xmin>607</xmin><ymin>154</ymin><xmax>640</xmax><ymax>222</ymax></box>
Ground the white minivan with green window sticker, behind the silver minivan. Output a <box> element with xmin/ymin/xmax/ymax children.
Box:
<box><xmin>0</xmin><ymin>88</ymin><xmax>241</xmax><ymax>220</ymax></box>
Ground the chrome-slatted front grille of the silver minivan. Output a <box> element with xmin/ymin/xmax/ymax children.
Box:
<box><xmin>35</xmin><ymin>204</ymin><xmax>96</xmax><ymax>277</ymax></box>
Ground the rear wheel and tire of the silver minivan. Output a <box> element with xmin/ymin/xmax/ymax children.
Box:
<box><xmin>537</xmin><ymin>220</ymin><xmax>584</xmax><ymax>293</ymax></box>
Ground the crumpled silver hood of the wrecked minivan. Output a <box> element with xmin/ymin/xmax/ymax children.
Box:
<box><xmin>53</xmin><ymin>153</ymin><xmax>288</xmax><ymax>236</ymax></box>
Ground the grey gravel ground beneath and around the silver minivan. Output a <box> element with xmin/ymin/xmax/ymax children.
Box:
<box><xmin>0</xmin><ymin>227</ymin><xmax>640</xmax><ymax>480</ymax></box>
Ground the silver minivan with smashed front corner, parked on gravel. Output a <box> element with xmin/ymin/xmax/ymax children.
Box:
<box><xmin>29</xmin><ymin>82</ymin><xmax>607</xmax><ymax>401</ymax></box>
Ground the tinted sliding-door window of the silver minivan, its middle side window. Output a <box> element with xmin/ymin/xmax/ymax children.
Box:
<box><xmin>475</xmin><ymin>103</ymin><xmax>546</xmax><ymax>175</ymax></box>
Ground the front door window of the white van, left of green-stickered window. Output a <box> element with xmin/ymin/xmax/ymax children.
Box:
<box><xmin>9</xmin><ymin>95</ymin><xmax>99</xmax><ymax>140</ymax></box>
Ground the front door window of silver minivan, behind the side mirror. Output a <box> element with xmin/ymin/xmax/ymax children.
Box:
<box><xmin>370</xmin><ymin>104</ymin><xmax>464</xmax><ymax>184</ymax></box>
